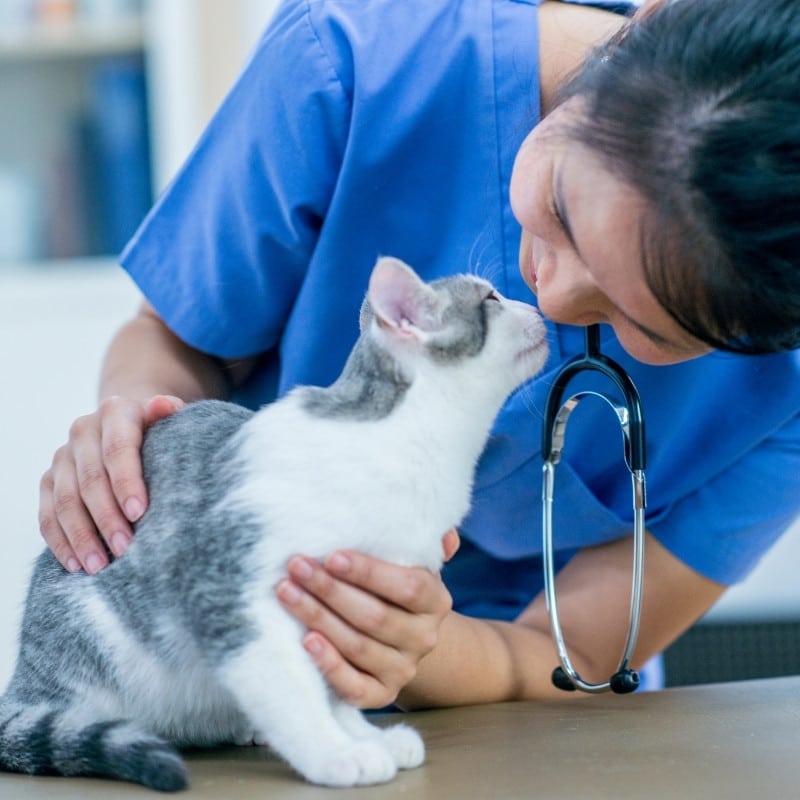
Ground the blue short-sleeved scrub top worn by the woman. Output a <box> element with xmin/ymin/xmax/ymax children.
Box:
<box><xmin>123</xmin><ymin>0</ymin><xmax>800</xmax><ymax>648</ymax></box>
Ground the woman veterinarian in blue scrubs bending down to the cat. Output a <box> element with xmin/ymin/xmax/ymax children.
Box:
<box><xmin>40</xmin><ymin>0</ymin><xmax>800</xmax><ymax>708</ymax></box>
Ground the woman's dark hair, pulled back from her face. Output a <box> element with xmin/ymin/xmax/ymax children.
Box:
<box><xmin>562</xmin><ymin>0</ymin><xmax>800</xmax><ymax>353</ymax></box>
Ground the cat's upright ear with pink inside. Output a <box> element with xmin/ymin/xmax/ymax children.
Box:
<box><xmin>367</xmin><ymin>257</ymin><xmax>441</xmax><ymax>339</ymax></box>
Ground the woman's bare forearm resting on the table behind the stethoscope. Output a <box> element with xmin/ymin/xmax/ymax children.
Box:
<box><xmin>400</xmin><ymin>533</ymin><xmax>725</xmax><ymax>708</ymax></box>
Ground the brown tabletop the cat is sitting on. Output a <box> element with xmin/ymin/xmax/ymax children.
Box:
<box><xmin>0</xmin><ymin>677</ymin><xmax>800</xmax><ymax>800</ymax></box>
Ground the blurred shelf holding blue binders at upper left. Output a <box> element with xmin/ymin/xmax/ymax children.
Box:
<box><xmin>0</xmin><ymin>0</ymin><xmax>153</xmax><ymax>269</ymax></box>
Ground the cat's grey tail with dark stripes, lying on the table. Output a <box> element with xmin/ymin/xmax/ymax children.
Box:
<box><xmin>0</xmin><ymin>697</ymin><xmax>189</xmax><ymax>792</ymax></box>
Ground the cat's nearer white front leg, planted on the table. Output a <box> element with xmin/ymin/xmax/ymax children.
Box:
<box><xmin>220</xmin><ymin>620</ymin><xmax>397</xmax><ymax>787</ymax></box>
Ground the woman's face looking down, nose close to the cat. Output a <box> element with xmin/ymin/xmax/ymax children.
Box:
<box><xmin>511</xmin><ymin>102</ymin><xmax>710</xmax><ymax>364</ymax></box>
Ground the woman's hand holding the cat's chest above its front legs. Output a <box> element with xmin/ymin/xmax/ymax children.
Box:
<box><xmin>277</xmin><ymin>530</ymin><xmax>459</xmax><ymax>708</ymax></box>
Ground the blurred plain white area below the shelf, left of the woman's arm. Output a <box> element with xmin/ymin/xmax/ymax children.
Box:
<box><xmin>0</xmin><ymin>263</ymin><xmax>138</xmax><ymax>686</ymax></box>
